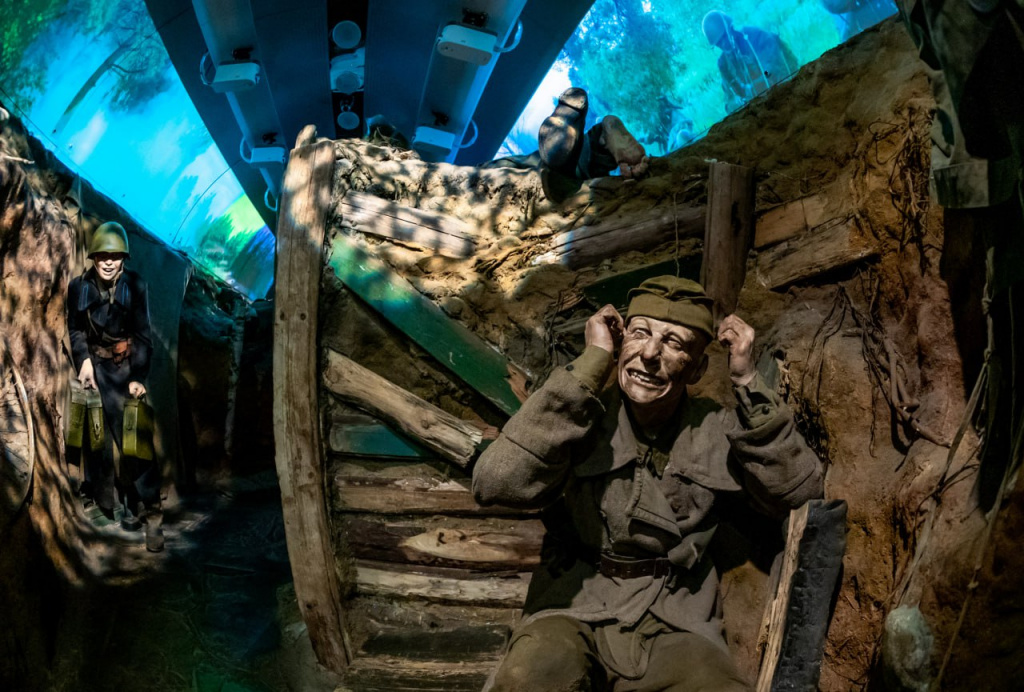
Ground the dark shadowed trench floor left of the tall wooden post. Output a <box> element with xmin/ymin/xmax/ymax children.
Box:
<box><xmin>68</xmin><ymin>470</ymin><xmax>335</xmax><ymax>692</ymax></box>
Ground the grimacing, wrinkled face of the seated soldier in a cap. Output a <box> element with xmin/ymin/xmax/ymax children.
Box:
<box><xmin>618</xmin><ymin>317</ymin><xmax>708</xmax><ymax>407</ymax></box>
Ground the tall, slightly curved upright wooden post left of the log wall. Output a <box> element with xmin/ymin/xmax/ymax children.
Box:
<box><xmin>273</xmin><ymin>128</ymin><xmax>350</xmax><ymax>672</ymax></box>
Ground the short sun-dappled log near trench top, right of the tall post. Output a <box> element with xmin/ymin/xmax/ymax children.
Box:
<box><xmin>338</xmin><ymin>190</ymin><xmax>476</xmax><ymax>259</ymax></box>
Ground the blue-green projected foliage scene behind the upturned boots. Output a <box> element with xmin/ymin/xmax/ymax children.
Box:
<box><xmin>500</xmin><ymin>0</ymin><xmax>896</xmax><ymax>156</ymax></box>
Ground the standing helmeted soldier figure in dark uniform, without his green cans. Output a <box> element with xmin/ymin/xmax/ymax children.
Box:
<box><xmin>68</xmin><ymin>221</ymin><xmax>164</xmax><ymax>552</ymax></box>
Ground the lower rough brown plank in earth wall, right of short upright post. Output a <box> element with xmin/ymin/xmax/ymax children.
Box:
<box><xmin>755</xmin><ymin>218</ymin><xmax>879</xmax><ymax>289</ymax></box>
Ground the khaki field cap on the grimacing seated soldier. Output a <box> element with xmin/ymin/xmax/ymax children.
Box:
<box><xmin>626</xmin><ymin>276</ymin><xmax>715</xmax><ymax>341</ymax></box>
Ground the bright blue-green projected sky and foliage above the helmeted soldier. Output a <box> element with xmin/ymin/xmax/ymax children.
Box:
<box><xmin>0</xmin><ymin>0</ymin><xmax>273</xmax><ymax>298</ymax></box>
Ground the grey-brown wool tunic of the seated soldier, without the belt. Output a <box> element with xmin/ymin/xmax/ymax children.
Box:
<box><xmin>473</xmin><ymin>347</ymin><xmax>822</xmax><ymax>646</ymax></box>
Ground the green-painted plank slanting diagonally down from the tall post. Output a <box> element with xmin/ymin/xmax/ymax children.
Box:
<box><xmin>328</xmin><ymin>233</ymin><xmax>519</xmax><ymax>415</ymax></box>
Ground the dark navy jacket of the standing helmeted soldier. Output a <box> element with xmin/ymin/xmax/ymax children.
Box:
<box><xmin>68</xmin><ymin>268</ymin><xmax>153</xmax><ymax>446</ymax></box>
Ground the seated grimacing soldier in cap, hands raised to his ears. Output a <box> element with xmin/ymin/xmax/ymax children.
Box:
<box><xmin>473</xmin><ymin>276</ymin><xmax>822</xmax><ymax>692</ymax></box>
